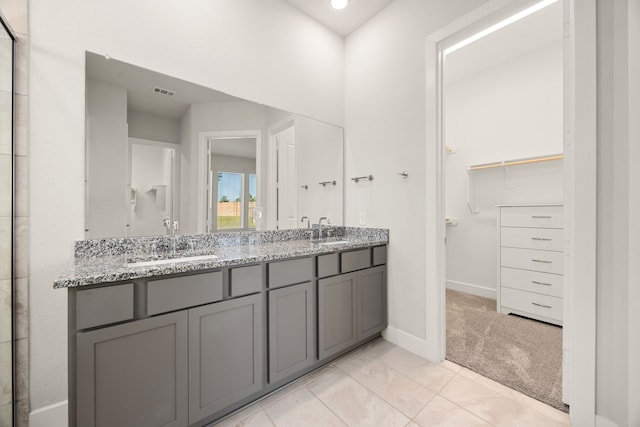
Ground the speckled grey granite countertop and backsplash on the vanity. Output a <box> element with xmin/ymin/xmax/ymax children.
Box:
<box><xmin>53</xmin><ymin>227</ymin><xmax>389</xmax><ymax>288</ymax></box>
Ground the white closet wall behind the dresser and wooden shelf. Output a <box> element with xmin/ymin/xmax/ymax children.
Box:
<box><xmin>444</xmin><ymin>41</ymin><xmax>563</xmax><ymax>298</ymax></box>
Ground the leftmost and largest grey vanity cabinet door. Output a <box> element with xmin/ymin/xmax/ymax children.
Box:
<box><xmin>76</xmin><ymin>311</ymin><xmax>188</xmax><ymax>427</ymax></box>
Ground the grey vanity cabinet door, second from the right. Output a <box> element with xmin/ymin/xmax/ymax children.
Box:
<box><xmin>318</xmin><ymin>273</ymin><xmax>358</xmax><ymax>360</ymax></box>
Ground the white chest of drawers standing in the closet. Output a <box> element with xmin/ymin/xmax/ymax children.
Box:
<box><xmin>497</xmin><ymin>204</ymin><xmax>564</xmax><ymax>325</ymax></box>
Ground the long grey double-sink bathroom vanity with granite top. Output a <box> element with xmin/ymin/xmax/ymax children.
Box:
<box><xmin>54</xmin><ymin>227</ymin><xmax>388</xmax><ymax>427</ymax></box>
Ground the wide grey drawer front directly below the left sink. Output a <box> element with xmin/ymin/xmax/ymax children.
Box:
<box><xmin>147</xmin><ymin>271</ymin><xmax>222</xmax><ymax>316</ymax></box>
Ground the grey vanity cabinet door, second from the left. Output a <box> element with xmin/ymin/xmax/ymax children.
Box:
<box><xmin>189</xmin><ymin>294</ymin><xmax>263</xmax><ymax>423</ymax></box>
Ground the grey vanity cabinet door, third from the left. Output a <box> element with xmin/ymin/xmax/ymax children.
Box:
<box><xmin>269</xmin><ymin>282</ymin><xmax>315</xmax><ymax>384</ymax></box>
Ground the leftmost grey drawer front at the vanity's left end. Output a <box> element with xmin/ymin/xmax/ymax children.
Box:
<box><xmin>76</xmin><ymin>283</ymin><xmax>133</xmax><ymax>329</ymax></box>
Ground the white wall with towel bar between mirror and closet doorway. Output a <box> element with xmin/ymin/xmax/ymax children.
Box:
<box><xmin>345</xmin><ymin>0</ymin><xmax>484</xmax><ymax>351</ymax></box>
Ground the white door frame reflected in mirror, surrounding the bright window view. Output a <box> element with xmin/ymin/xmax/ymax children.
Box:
<box><xmin>196</xmin><ymin>130</ymin><xmax>264</xmax><ymax>234</ymax></box>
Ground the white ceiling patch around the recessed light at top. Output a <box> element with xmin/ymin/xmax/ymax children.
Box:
<box><xmin>284</xmin><ymin>0</ymin><xmax>393</xmax><ymax>37</ymax></box>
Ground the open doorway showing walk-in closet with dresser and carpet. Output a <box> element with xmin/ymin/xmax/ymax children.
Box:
<box><xmin>442</xmin><ymin>0</ymin><xmax>568</xmax><ymax>411</ymax></box>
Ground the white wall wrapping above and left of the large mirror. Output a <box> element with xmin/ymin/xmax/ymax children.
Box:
<box><xmin>29</xmin><ymin>0</ymin><xmax>344</xmax><ymax>416</ymax></box>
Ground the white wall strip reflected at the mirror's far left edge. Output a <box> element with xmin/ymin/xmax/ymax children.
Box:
<box><xmin>85</xmin><ymin>80</ymin><xmax>129</xmax><ymax>239</ymax></box>
